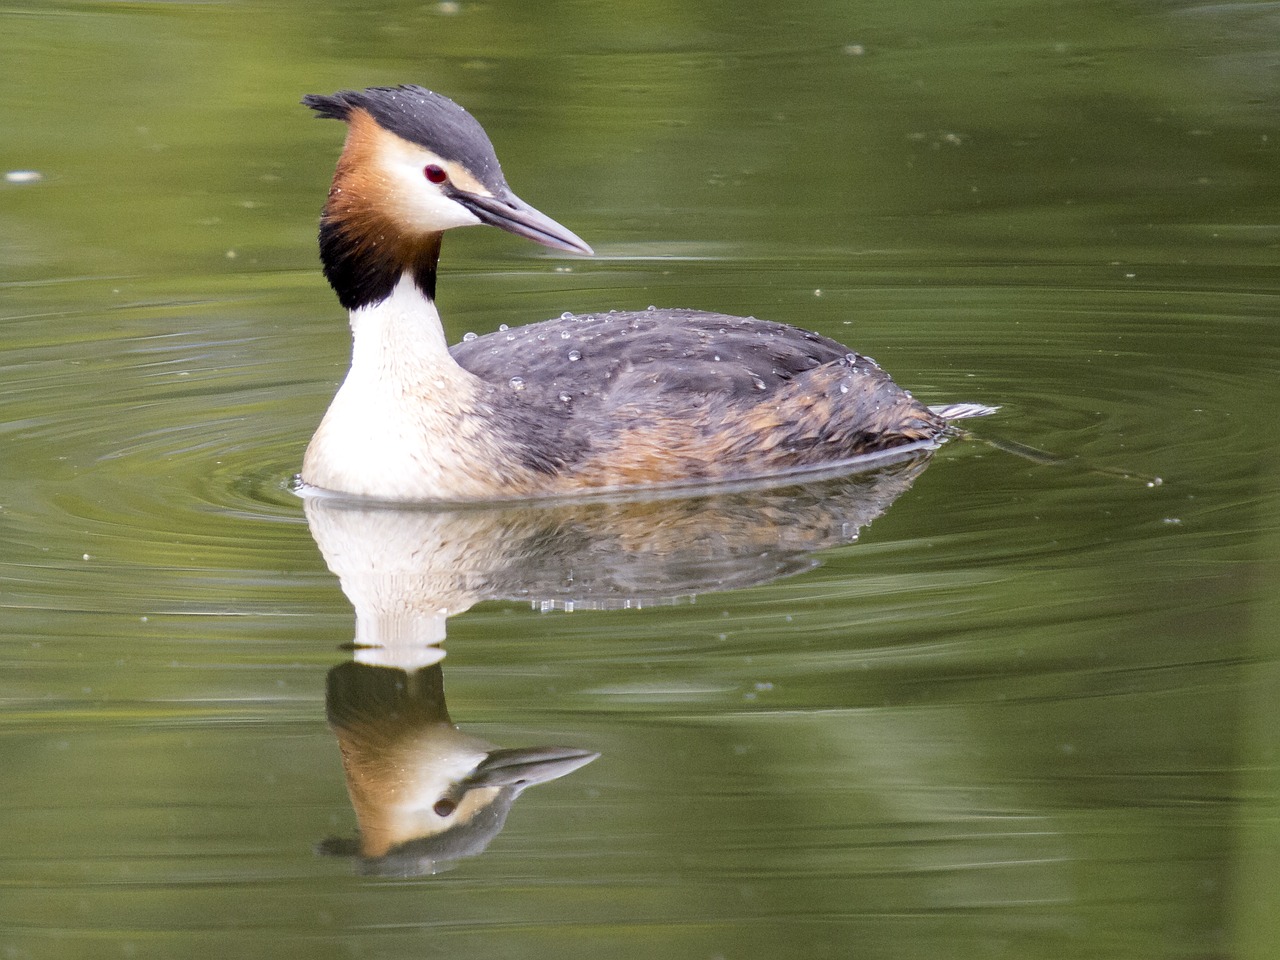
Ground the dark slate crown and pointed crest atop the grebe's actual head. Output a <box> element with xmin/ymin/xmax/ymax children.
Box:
<box><xmin>302</xmin><ymin>84</ymin><xmax>507</xmax><ymax>193</ymax></box>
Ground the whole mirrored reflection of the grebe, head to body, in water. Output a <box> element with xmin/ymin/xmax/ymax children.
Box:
<box><xmin>306</xmin><ymin>451</ymin><xmax>929</xmax><ymax>876</ymax></box>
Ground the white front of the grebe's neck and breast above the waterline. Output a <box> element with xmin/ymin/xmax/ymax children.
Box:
<box><xmin>302</xmin><ymin>268</ymin><xmax>480</xmax><ymax>499</ymax></box>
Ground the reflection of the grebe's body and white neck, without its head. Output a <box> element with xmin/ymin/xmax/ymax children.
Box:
<box><xmin>305</xmin><ymin>452</ymin><xmax>929</xmax><ymax>634</ymax></box>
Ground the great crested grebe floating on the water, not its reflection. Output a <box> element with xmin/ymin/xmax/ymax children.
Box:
<box><xmin>302</xmin><ymin>86</ymin><xmax>991</xmax><ymax>500</ymax></box>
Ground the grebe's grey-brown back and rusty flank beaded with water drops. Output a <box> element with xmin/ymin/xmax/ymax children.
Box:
<box><xmin>452</xmin><ymin>310</ymin><xmax>946</xmax><ymax>486</ymax></box>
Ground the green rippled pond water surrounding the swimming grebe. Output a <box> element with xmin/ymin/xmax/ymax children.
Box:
<box><xmin>0</xmin><ymin>0</ymin><xmax>1280</xmax><ymax>960</ymax></box>
